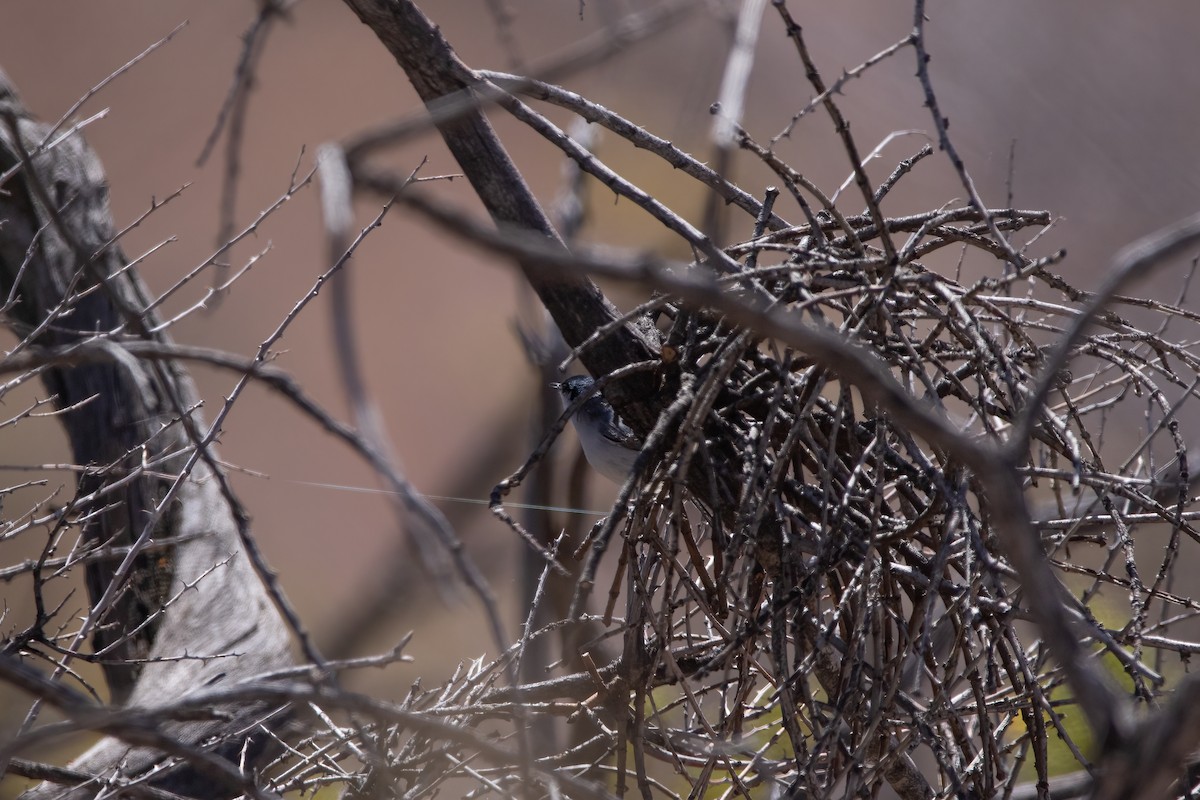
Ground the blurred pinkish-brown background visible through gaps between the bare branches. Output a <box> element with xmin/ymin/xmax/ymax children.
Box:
<box><xmin>0</xmin><ymin>0</ymin><xmax>1200</xmax><ymax>762</ymax></box>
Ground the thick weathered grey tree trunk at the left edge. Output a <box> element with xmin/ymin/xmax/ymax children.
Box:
<box><xmin>0</xmin><ymin>73</ymin><xmax>292</xmax><ymax>798</ymax></box>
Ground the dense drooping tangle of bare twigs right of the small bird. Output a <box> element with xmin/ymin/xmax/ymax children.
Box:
<box><xmin>480</xmin><ymin>199</ymin><xmax>1196</xmax><ymax>796</ymax></box>
